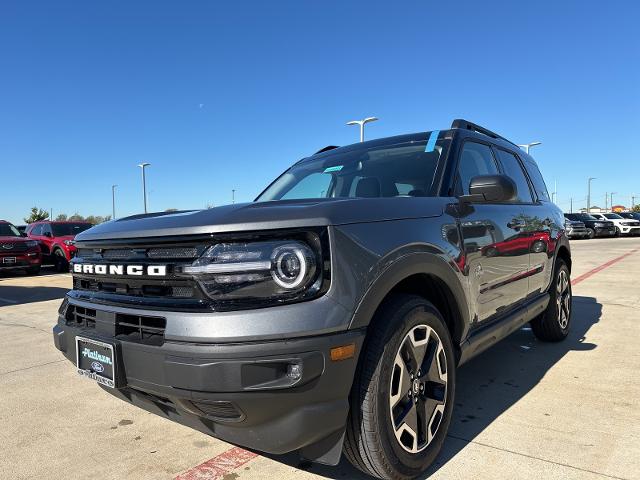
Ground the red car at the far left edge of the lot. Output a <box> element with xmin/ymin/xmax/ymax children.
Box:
<box><xmin>0</xmin><ymin>220</ymin><xmax>42</xmax><ymax>274</ymax></box>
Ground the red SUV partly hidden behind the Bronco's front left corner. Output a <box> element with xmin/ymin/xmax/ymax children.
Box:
<box><xmin>27</xmin><ymin>221</ymin><xmax>93</xmax><ymax>272</ymax></box>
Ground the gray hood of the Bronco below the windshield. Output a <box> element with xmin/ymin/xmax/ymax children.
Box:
<box><xmin>76</xmin><ymin>197</ymin><xmax>451</xmax><ymax>242</ymax></box>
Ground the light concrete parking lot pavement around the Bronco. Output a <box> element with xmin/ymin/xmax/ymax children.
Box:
<box><xmin>0</xmin><ymin>238</ymin><xmax>640</xmax><ymax>480</ymax></box>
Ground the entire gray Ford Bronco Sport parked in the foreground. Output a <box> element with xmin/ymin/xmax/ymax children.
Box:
<box><xmin>53</xmin><ymin>120</ymin><xmax>571</xmax><ymax>479</ymax></box>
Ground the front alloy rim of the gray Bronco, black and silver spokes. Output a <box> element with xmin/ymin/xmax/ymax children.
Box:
<box><xmin>389</xmin><ymin>325</ymin><xmax>448</xmax><ymax>453</ymax></box>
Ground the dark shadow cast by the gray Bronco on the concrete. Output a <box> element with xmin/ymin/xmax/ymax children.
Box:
<box><xmin>274</xmin><ymin>296</ymin><xmax>602</xmax><ymax>480</ymax></box>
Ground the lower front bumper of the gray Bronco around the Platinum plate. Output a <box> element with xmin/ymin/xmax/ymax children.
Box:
<box><xmin>53</xmin><ymin>312</ymin><xmax>364</xmax><ymax>463</ymax></box>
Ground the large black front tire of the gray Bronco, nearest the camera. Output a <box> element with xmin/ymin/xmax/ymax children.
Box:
<box><xmin>344</xmin><ymin>294</ymin><xmax>456</xmax><ymax>480</ymax></box>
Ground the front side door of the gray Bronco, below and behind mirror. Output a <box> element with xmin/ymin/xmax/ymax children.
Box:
<box><xmin>455</xmin><ymin>139</ymin><xmax>530</xmax><ymax>323</ymax></box>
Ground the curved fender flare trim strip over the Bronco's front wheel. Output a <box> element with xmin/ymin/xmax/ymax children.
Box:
<box><xmin>349</xmin><ymin>252</ymin><xmax>471</xmax><ymax>348</ymax></box>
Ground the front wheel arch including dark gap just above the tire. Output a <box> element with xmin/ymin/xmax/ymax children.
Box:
<box><xmin>350</xmin><ymin>252</ymin><xmax>470</xmax><ymax>353</ymax></box>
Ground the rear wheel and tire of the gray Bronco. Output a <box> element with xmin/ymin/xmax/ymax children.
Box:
<box><xmin>531</xmin><ymin>258</ymin><xmax>573</xmax><ymax>342</ymax></box>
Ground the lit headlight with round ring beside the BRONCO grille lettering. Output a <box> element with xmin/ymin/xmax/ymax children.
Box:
<box><xmin>176</xmin><ymin>232</ymin><xmax>330</xmax><ymax>310</ymax></box>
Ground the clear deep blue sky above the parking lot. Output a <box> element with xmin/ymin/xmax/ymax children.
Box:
<box><xmin>0</xmin><ymin>0</ymin><xmax>640</xmax><ymax>223</ymax></box>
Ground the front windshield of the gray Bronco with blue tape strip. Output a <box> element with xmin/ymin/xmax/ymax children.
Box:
<box><xmin>256</xmin><ymin>133</ymin><xmax>449</xmax><ymax>202</ymax></box>
